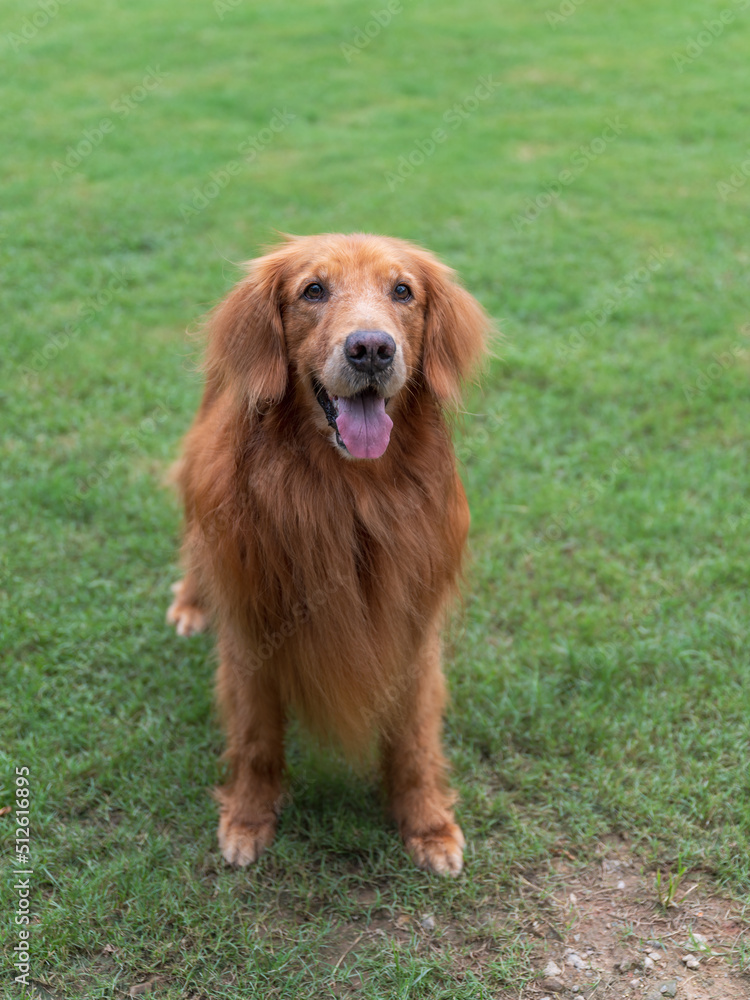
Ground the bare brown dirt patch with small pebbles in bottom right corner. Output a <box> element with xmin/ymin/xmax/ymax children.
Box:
<box><xmin>516</xmin><ymin>850</ymin><xmax>750</xmax><ymax>1000</ymax></box>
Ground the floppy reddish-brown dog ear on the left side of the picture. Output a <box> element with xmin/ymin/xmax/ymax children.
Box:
<box><xmin>203</xmin><ymin>254</ymin><xmax>288</xmax><ymax>408</ymax></box>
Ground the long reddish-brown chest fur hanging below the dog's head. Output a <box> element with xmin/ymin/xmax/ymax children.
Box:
<box><xmin>200</xmin><ymin>394</ymin><xmax>468</xmax><ymax>748</ymax></box>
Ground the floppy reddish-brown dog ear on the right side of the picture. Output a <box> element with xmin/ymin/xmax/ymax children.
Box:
<box><xmin>422</xmin><ymin>255</ymin><xmax>492</xmax><ymax>405</ymax></box>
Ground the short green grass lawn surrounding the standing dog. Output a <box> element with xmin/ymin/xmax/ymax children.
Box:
<box><xmin>0</xmin><ymin>0</ymin><xmax>750</xmax><ymax>1000</ymax></box>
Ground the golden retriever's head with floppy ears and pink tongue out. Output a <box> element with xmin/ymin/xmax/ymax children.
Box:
<box><xmin>206</xmin><ymin>234</ymin><xmax>488</xmax><ymax>458</ymax></box>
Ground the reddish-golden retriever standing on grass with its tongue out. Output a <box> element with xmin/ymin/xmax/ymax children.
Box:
<box><xmin>168</xmin><ymin>234</ymin><xmax>490</xmax><ymax>875</ymax></box>
